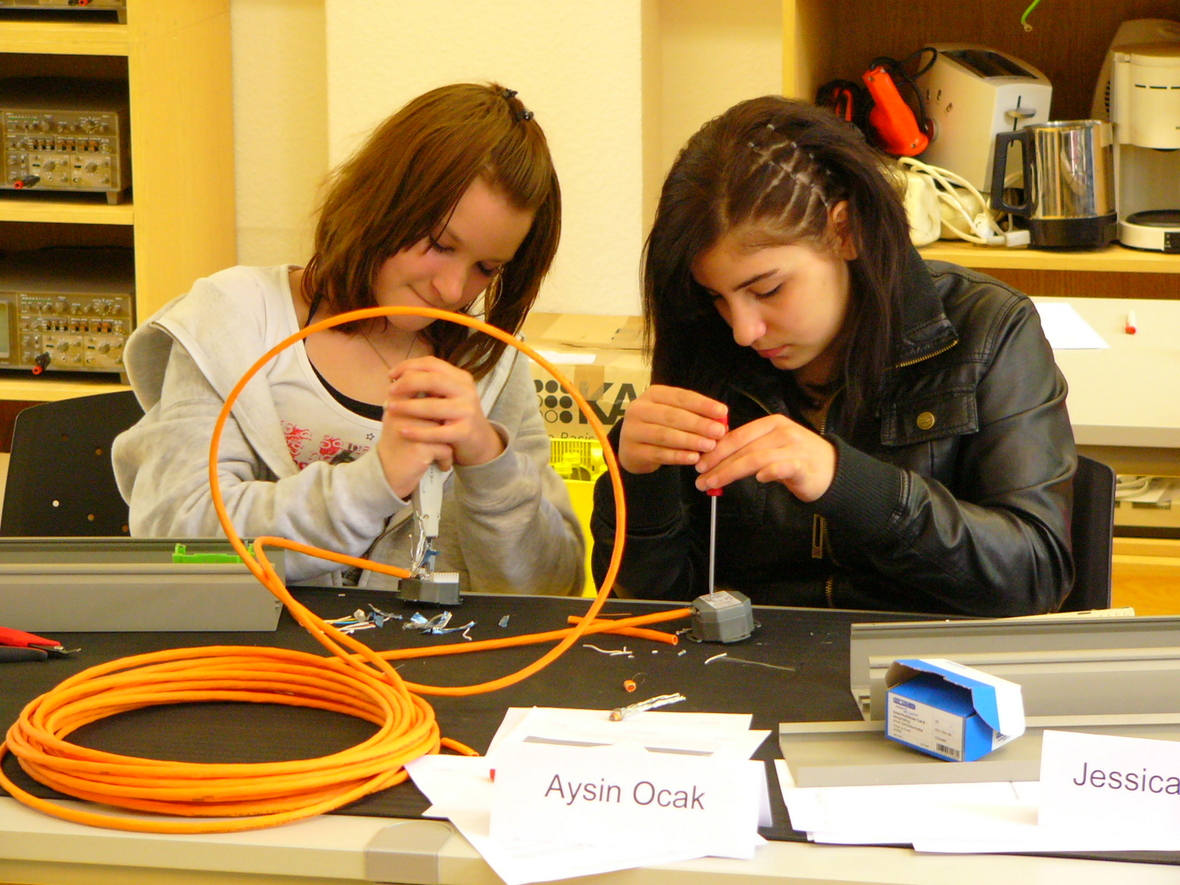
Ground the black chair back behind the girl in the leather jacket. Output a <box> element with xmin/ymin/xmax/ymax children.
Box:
<box><xmin>1060</xmin><ymin>454</ymin><xmax>1115</xmax><ymax>611</ymax></box>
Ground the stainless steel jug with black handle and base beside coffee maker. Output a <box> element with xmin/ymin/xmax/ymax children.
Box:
<box><xmin>991</xmin><ymin>120</ymin><xmax>1117</xmax><ymax>249</ymax></box>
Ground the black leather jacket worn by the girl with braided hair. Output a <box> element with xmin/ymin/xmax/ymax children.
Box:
<box><xmin>591</xmin><ymin>261</ymin><xmax>1076</xmax><ymax>617</ymax></box>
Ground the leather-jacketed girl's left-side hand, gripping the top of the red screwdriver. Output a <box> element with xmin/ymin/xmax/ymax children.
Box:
<box><xmin>618</xmin><ymin>385</ymin><xmax>729</xmax><ymax>473</ymax></box>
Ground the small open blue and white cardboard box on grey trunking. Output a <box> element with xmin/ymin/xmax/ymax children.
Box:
<box><xmin>885</xmin><ymin>657</ymin><xmax>1024</xmax><ymax>762</ymax></box>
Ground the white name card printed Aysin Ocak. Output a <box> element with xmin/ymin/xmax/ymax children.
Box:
<box><xmin>490</xmin><ymin>743</ymin><xmax>766</xmax><ymax>859</ymax></box>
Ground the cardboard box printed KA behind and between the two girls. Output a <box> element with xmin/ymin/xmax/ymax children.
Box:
<box><xmin>523</xmin><ymin>313</ymin><xmax>650</xmax><ymax>439</ymax></box>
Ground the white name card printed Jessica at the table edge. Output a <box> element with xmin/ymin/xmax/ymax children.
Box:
<box><xmin>1038</xmin><ymin>730</ymin><xmax>1180</xmax><ymax>850</ymax></box>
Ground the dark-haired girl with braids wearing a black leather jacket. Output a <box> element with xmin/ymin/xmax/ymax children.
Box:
<box><xmin>591</xmin><ymin>97</ymin><xmax>1076</xmax><ymax>616</ymax></box>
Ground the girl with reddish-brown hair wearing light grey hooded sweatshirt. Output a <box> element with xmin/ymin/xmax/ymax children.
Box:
<box><xmin>113</xmin><ymin>84</ymin><xmax>583</xmax><ymax>594</ymax></box>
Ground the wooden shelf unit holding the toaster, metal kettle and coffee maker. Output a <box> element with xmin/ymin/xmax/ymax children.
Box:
<box><xmin>782</xmin><ymin>0</ymin><xmax>1180</xmax><ymax>299</ymax></box>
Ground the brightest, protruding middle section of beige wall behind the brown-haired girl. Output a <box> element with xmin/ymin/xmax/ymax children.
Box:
<box><xmin>326</xmin><ymin>0</ymin><xmax>643</xmax><ymax>313</ymax></box>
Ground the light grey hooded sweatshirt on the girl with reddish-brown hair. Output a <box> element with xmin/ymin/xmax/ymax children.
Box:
<box><xmin>112</xmin><ymin>266</ymin><xmax>584</xmax><ymax>595</ymax></box>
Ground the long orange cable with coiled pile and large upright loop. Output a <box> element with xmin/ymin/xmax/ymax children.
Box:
<box><xmin>0</xmin><ymin>307</ymin><xmax>690</xmax><ymax>833</ymax></box>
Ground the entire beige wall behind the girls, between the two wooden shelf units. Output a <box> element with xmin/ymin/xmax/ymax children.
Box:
<box><xmin>231</xmin><ymin>0</ymin><xmax>781</xmax><ymax>314</ymax></box>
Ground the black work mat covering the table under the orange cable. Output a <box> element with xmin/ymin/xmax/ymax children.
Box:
<box><xmin>0</xmin><ymin>589</ymin><xmax>897</xmax><ymax>840</ymax></box>
